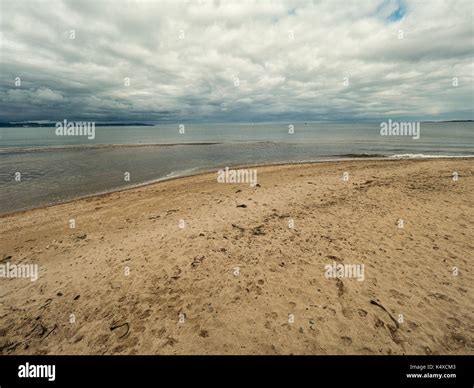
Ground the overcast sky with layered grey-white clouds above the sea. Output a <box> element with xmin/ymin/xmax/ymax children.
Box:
<box><xmin>0</xmin><ymin>0</ymin><xmax>474</xmax><ymax>123</ymax></box>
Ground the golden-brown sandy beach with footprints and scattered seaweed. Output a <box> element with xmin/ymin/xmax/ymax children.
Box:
<box><xmin>0</xmin><ymin>159</ymin><xmax>474</xmax><ymax>354</ymax></box>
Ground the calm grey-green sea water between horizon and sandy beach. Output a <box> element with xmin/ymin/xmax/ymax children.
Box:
<box><xmin>0</xmin><ymin>122</ymin><xmax>474</xmax><ymax>213</ymax></box>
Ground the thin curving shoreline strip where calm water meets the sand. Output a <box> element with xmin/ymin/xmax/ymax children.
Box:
<box><xmin>0</xmin><ymin>155</ymin><xmax>474</xmax><ymax>219</ymax></box>
